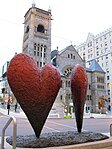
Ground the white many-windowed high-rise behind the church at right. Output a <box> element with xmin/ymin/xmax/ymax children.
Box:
<box><xmin>76</xmin><ymin>28</ymin><xmax>112</xmax><ymax>106</ymax></box>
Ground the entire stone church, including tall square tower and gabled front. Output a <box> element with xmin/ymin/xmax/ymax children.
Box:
<box><xmin>22</xmin><ymin>4</ymin><xmax>105</xmax><ymax>117</ymax></box>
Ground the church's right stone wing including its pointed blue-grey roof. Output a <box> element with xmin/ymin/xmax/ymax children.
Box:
<box><xmin>86</xmin><ymin>59</ymin><xmax>107</xmax><ymax>113</ymax></box>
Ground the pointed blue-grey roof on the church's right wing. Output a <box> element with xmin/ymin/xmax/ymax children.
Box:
<box><xmin>89</xmin><ymin>59</ymin><xmax>105</xmax><ymax>73</ymax></box>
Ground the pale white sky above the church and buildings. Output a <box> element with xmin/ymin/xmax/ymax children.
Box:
<box><xmin>0</xmin><ymin>0</ymin><xmax>112</xmax><ymax>75</ymax></box>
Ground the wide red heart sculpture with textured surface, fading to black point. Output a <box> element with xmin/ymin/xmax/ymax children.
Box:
<box><xmin>7</xmin><ymin>53</ymin><xmax>61</xmax><ymax>137</ymax></box>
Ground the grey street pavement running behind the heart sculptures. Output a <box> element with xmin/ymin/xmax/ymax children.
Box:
<box><xmin>0</xmin><ymin>116</ymin><xmax>112</xmax><ymax>136</ymax></box>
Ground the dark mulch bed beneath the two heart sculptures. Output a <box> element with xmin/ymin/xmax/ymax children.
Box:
<box><xmin>6</xmin><ymin>131</ymin><xmax>109</xmax><ymax>149</ymax></box>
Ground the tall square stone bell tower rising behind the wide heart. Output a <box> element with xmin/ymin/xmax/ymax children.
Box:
<box><xmin>22</xmin><ymin>3</ymin><xmax>51</xmax><ymax>67</ymax></box>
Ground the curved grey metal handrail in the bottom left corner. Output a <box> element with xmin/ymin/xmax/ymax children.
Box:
<box><xmin>1</xmin><ymin>116</ymin><xmax>17</xmax><ymax>149</ymax></box>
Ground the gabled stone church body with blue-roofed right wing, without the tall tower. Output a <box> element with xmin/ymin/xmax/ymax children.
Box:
<box><xmin>51</xmin><ymin>45</ymin><xmax>106</xmax><ymax>117</ymax></box>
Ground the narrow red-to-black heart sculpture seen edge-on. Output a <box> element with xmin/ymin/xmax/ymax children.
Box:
<box><xmin>71</xmin><ymin>64</ymin><xmax>88</xmax><ymax>133</ymax></box>
